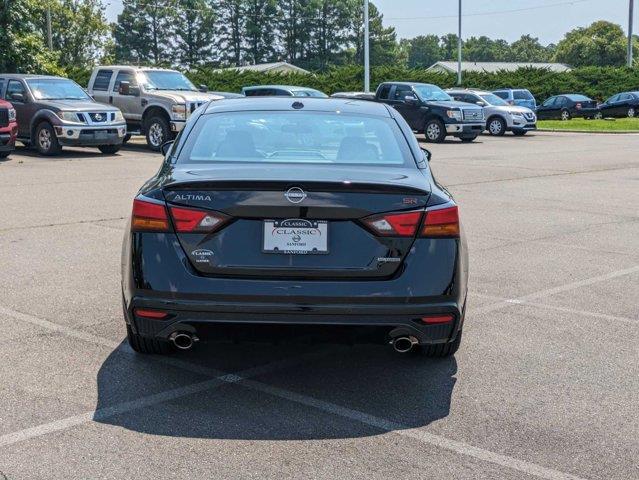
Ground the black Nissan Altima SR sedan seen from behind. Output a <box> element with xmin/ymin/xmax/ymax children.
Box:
<box><xmin>122</xmin><ymin>97</ymin><xmax>468</xmax><ymax>357</ymax></box>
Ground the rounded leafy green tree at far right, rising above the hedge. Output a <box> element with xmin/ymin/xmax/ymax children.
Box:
<box><xmin>555</xmin><ymin>20</ymin><xmax>627</xmax><ymax>67</ymax></box>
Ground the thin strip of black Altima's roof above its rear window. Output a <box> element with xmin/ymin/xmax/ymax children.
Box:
<box><xmin>204</xmin><ymin>97</ymin><xmax>391</xmax><ymax>118</ymax></box>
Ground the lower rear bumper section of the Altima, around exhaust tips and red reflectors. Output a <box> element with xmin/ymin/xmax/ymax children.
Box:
<box><xmin>125</xmin><ymin>296</ymin><xmax>463</xmax><ymax>345</ymax></box>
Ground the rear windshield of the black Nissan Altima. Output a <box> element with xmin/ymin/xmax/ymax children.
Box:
<box><xmin>177</xmin><ymin>111</ymin><xmax>415</xmax><ymax>166</ymax></box>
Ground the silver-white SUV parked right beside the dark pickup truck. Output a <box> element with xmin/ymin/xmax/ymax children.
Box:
<box><xmin>446</xmin><ymin>89</ymin><xmax>537</xmax><ymax>136</ymax></box>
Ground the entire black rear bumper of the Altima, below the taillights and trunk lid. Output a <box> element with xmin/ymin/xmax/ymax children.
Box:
<box><xmin>122</xmin><ymin>232</ymin><xmax>468</xmax><ymax>344</ymax></box>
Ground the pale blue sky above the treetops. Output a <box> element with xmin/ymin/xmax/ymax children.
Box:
<box><xmin>107</xmin><ymin>0</ymin><xmax>639</xmax><ymax>43</ymax></box>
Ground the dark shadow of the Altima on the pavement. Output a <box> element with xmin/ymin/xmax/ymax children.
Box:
<box><xmin>94</xmin><ymin>343</ymin><xmax>457</xmax><ymax>440</ymax></box>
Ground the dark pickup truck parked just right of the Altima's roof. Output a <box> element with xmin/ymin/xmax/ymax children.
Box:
<box><xmin>375</xmin><ymin>82</ymin><xmax>486</xmax><ymax>143</ymax></box>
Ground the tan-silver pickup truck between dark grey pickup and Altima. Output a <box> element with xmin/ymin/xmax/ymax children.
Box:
<box><xmin>88</xmin><ymin>65</ymin><xmax>223</xmax><ymax>151</ymax></box>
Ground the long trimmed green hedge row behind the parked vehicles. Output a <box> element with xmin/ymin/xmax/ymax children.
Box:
<box><xmin>68</xmin><ymin>66</ymin><xmax>639</xmax><ymax>101</ymax></box>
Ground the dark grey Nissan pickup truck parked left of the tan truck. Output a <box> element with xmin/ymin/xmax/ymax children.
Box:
<box><xmin>0</xmin><ymin>73</ymin><xmax>126</xmax><ymax>155</ymax></box>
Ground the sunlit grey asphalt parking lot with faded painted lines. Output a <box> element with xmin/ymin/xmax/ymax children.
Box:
<box><xmin>0</xmin><ymin>133</ymin><xmax>639</xmax><ymax>480</ymax></box>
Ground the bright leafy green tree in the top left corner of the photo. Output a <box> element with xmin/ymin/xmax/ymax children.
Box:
<box><xmin>0</xmin><ymin>0</ymin><xmax>62</xmax><ymax>74</ymax></box>
